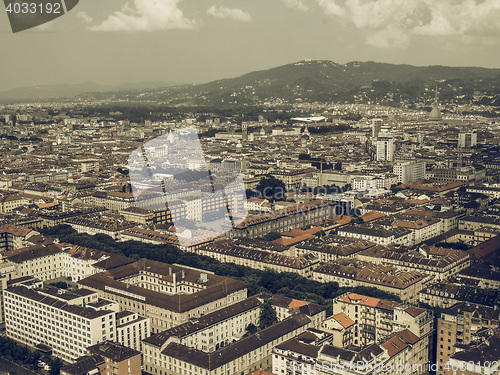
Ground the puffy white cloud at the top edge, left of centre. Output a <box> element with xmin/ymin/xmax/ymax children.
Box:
<box><xmin>89</xmin><ymin>0</ymin><xmax>195</xmax><ymax>31</ymax></box>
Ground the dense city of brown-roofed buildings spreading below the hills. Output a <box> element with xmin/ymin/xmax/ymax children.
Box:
<box><xmin>0</xmin><ymin>68</ymin><xmax>500</xmax><ymax>375</ymax></box>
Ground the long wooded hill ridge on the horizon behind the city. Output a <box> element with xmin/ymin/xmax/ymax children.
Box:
<box><xmin>0</xmin><ymin>60</ymin><xmax>500</xmax><ymax>106</ymax></box>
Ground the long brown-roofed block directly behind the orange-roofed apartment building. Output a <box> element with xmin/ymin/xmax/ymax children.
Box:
<box><xmin>312</xmin><ymin>259</ymin><xmax>431</xmax><ymax>303</ymax></box>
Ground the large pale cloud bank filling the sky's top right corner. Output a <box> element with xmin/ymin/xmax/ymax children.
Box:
<box><xmin>316</xmin><ymin>0</ymin><xmax>500</xmax><ymax>48</ymax></box>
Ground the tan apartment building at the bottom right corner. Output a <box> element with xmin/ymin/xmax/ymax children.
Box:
<box><xmin>436</xmin><ymin>302</ymin><xmax>500</xmax><ymax>374</ymax></box>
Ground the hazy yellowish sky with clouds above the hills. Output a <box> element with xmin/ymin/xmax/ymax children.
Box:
<box><xmin>0</xmin><ymin>0</ymin><xmax>500</xmax><ymax>91</ymax></box>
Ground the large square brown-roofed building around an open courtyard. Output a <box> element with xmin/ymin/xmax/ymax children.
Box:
<box><xmin>78</xmin><ymin>259</ymin><xmax>247</xmax><ymax>332</ymax></box>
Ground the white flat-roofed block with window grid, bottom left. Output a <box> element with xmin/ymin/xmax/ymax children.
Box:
<box><xmin>4</xmin><ymin>283</ymin><xmax>117</xmax><ymax>362</ymax></box>
